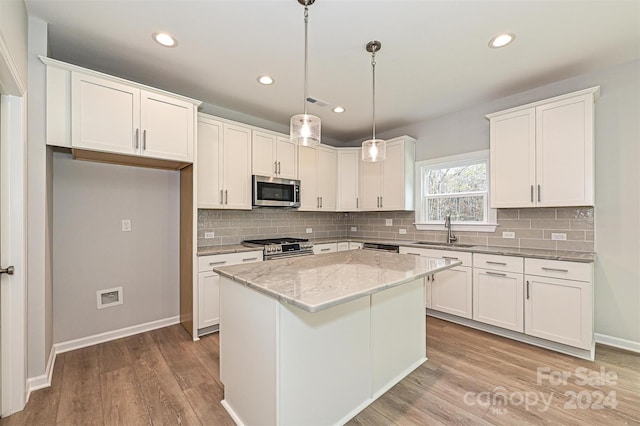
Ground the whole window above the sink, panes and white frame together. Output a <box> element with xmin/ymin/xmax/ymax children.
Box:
<box><xmin>416</xmin><ymin>151</ymin><xmax>496</xmax><ymax>231</ymax></box>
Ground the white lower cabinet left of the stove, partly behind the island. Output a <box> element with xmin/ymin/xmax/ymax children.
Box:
<box><xmin>197</xmin><ymin>251</ymin><xmax>262</xmax><ymax>335</ymax></box>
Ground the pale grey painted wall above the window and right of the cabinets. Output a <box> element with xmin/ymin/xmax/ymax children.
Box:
<box><xmin>370</xmin><ymin>61</ymin><xmax>640</xmax><ymax>344</ymax></box>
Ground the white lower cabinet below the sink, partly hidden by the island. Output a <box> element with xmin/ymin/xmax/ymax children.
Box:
<box><xmin>400</xmin><ymin>247</ymin><xmax>473</xmax><ymax>319</ymax></box>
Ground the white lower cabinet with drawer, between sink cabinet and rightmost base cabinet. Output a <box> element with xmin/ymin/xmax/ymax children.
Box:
<box><xmin>473</xmin><ymin>254</ymin><xmax>524</xmax><ymax>333</ymax></box>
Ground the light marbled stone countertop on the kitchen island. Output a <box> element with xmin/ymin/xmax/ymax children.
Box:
<box><xmin>213</xmin><ymin>250</ymin><xmax>462</xmax><ymax>312</ymax></box>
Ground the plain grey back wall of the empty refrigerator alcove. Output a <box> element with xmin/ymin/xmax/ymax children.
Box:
<box><xmin>53</xmin><ymin>152</ymin><xmax>180</xmax><ymax>343</ymax></box>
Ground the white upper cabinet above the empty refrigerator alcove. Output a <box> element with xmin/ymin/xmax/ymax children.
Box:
<box><xmin>41</xmin><ymin>57</ymin><xmax>200</xmax><ymax>168</ymax></box>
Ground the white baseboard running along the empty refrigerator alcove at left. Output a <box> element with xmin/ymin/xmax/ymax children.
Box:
<box><xmin>27</xmin><ymin>316</ymin><xmax>180</xmax><ymax>394</ymax></box>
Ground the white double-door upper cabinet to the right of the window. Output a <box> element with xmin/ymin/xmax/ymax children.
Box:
<box><xmin>487</xmin><ymin>87</ymin><xmax>599</xmax><ymax>208</ymax></box>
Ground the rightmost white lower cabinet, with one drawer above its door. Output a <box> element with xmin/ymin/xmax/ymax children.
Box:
<box><xmin>524</xmin><ymin>259</ymin><xmax>593</xmax><ymax>350</ymax></box>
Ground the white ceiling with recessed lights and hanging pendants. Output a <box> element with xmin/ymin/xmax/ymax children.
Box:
<box><xmin>25</xmin><ymin>0</ymin><xmax>640</xmax><ymax>145</ymax></box>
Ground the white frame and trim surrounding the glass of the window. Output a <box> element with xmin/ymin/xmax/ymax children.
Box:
<box><xmin>414</xmin><ymin>149</ymin><xmax>498</xmax><ymax>232</ymax></box>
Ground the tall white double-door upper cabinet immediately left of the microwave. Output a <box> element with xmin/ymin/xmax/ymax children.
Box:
<box><xmin>196</xmin><ymin>114</ymin><xmax>251</xmax><ymax>210</ymax></box>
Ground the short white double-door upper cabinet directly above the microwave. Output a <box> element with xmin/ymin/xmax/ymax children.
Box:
<box><xmin>252</xmin><ymin>130</ymin><xmax>298</xmax><ymax>179</ymax></box>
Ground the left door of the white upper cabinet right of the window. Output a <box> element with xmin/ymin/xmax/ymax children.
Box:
<box><xmin>489</xmin><ymin>108</ymin><xmax>536</xmax><ymax>208</ymax></box>
